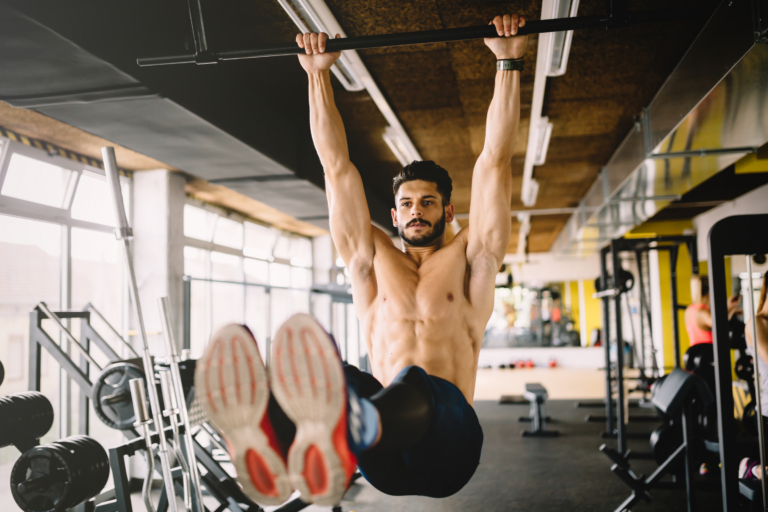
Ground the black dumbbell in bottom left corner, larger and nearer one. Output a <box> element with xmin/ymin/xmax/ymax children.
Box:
<box><xmin>11</xmin><ymin>436</ymin><xmax>109</xmax><ymax>512</ymax></box>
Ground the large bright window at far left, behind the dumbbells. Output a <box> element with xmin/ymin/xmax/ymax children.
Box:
<box><xmin>0</xmin><ymin>137</ymin><xmax>130</xmax><ymax>507</ymax></box>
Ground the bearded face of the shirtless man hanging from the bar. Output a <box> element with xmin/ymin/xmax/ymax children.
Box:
<box><xmin>392</xmin><ymin>180</ymin><xmax>453</xmax><ymax>247</ymax></box>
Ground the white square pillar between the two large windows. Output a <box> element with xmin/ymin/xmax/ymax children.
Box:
<box><xmin>131</xmin><ymin>169</ymin><xmax>186</xmax><ymax>356</ymax></box>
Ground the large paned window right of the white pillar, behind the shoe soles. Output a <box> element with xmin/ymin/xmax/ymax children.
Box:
<box><xmin>184</xmin><ymin>204</ymin><xmax>312</xmax><ymax>358</ymax></box>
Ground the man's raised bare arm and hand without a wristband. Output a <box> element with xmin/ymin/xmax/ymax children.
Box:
<box><xmin>296</xmin><ymin>34</ymin><xmax>373</xmax><ymax>274</ymax></box>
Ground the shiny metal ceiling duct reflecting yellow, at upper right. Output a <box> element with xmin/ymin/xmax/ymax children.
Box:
<box><xmin>551</xmin><ymin>1</ymin><xmax>768</xmax><ymax>255</ymax></box>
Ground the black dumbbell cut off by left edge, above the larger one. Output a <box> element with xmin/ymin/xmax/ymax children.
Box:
<box><xmin>0</xmin><ymin>391</ymin><xmax>53</xmax><ymax>453</ymax></box>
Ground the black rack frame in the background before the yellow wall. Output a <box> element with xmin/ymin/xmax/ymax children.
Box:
<box><xmin>588</xmin><ymin>235</ymin><xmax>699</xmax><ymax>458</ymax></box>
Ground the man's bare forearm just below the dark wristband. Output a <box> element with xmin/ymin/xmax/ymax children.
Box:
<box><xmin>483</xmin><ymin>71</ymin><xmax>520</xmax><ymax>165</ymax></box>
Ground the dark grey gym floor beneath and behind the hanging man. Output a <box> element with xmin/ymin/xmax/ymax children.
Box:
<box><xmin>286</xmin><ymin>400</ymin><xmax>722</xmax><ymax>512</ymax></box>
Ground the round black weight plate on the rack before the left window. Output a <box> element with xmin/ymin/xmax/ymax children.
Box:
<box><xmin>91</xmin><ymin>363</ymin><xmax>144</xmax><ymax>430</ymax></box>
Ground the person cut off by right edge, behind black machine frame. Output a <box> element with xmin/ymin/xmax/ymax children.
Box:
<box><xmin>739</xmin><ymin>277</ymin><xmax>768</xmax><ymax>480</ymax></box>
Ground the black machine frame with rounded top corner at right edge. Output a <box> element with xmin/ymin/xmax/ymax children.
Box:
<box><xmin>707</xmin><ymin>214</ymin><xmax>768</xmax><ymax>511</ymax></box>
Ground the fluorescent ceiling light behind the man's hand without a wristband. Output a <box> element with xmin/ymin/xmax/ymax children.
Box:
<box><xmin>277</xmin><ymin>0</ymin><xmax>365</xmax><ymax>91</ymax></box>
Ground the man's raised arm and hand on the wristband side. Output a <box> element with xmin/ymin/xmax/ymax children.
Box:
<box><xmin>467</xmin><ymin>14</ymin><xmax>526</xmax><ymax>284</ymax></box>
